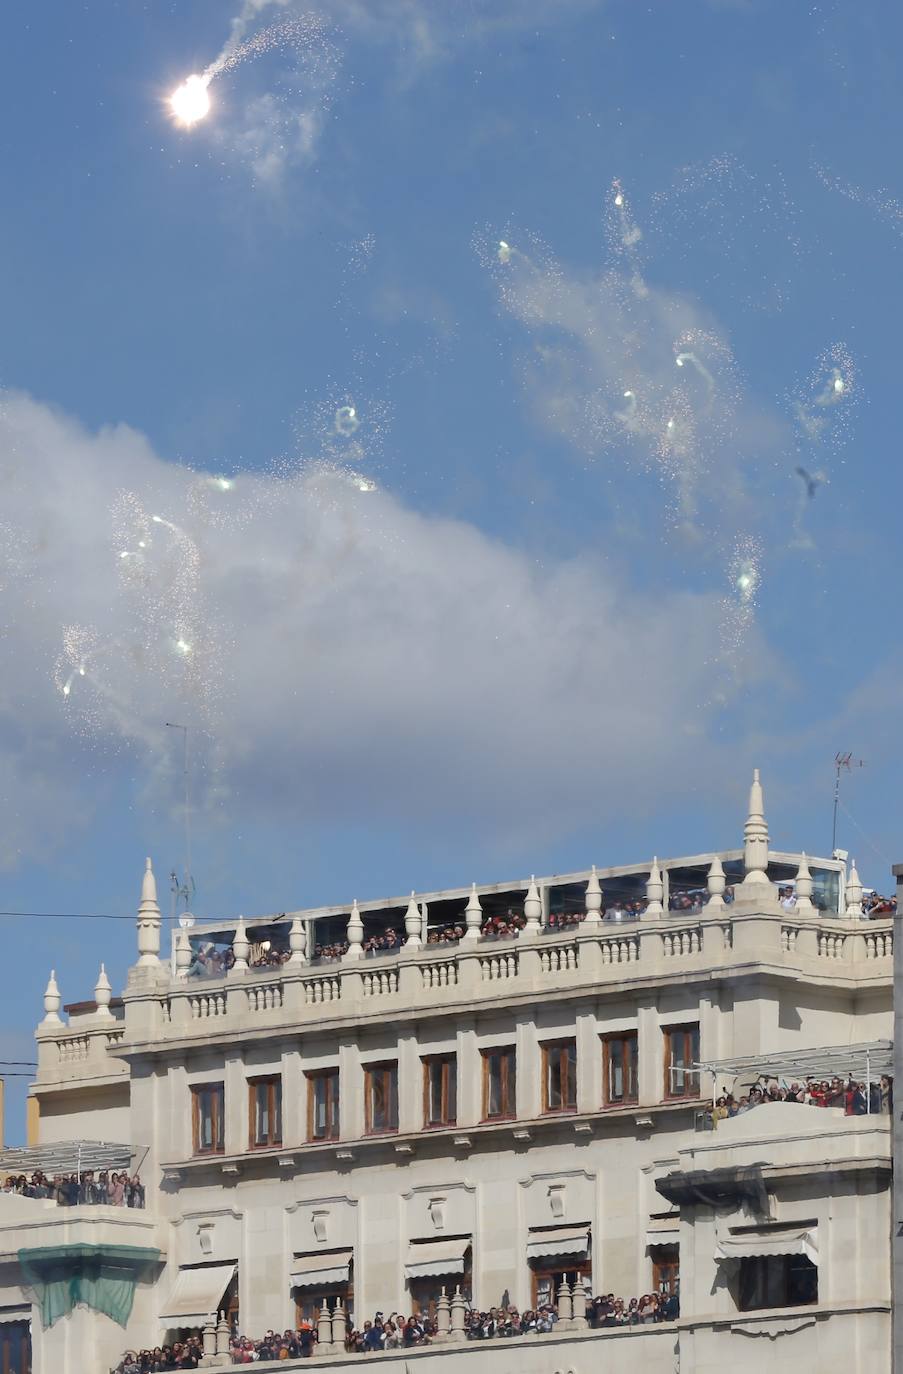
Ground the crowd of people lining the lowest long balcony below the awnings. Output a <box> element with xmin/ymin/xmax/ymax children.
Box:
<box><xmin>111</xmin><ymin>1293</ymin><xmax>680</xmax><ymax>1374</ymax></box>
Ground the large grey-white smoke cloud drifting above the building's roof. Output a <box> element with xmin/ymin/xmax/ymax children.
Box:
<box><xmin>0</xmin><ymin>394</ymin><xmax>753</xmax><ymax>866</ymax></box>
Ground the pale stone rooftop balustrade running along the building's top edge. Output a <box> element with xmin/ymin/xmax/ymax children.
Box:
<box><xmin>56</xmin><ymin>904</ymin><xmax>893</xmax><ymax>1060</ymax></box>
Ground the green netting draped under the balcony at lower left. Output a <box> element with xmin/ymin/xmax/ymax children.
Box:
<box><xmin>18</xmin><ymin>1245</ymin><xmax>159</xmax><ymax>1329</ymax></box>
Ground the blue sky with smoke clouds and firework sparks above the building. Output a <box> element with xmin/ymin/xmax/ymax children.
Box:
<box><xmin>0</xmin><ymin>0</ymin><xmax>903</xmax><ymax>1139</ymax></box>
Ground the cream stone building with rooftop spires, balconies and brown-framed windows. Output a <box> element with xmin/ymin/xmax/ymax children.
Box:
<box><xmin>0</xmin><ymin>776</ymin><xmax>893</xmax><ymax>1374</ymax></box>
